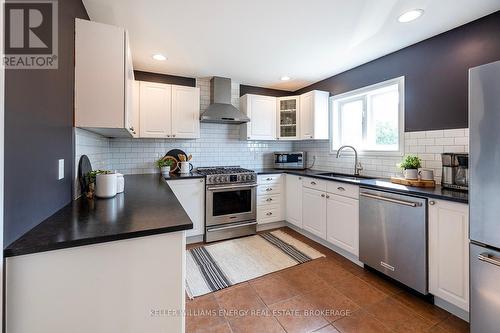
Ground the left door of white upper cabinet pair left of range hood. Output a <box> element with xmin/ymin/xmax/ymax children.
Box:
<box><xmin>139</xmin><ymin>82</ymin><xmax>172</xmax><ymax>138</ymax></box>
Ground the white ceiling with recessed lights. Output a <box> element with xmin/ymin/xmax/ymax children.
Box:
<box><xmin>83</xmin><ymin>0</ymin><xmax>500</xmax><ymax>91</ymax></box>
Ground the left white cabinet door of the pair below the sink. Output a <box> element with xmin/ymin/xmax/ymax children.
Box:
<box><xmin>302</xmin><ymin>187</ymin><xmax>326</xmax><ymax>239</ymax></box>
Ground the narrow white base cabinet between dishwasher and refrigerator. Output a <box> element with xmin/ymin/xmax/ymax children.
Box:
<box><xmin>429</xmin><ymin>199</ymin><xmax>469</xmax><ymax>311</ymax></box>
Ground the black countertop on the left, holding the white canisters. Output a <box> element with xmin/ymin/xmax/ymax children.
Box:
<box><xmin>4</xmin><ymin>174</ymin><xmax>194</xmax><ymax>257</ymax></box>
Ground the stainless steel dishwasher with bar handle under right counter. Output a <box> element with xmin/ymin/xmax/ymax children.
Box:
<box><xmin>359</xmin><ymin>187</ymin><xmax>428</xmax><ymax>294</ymax></box>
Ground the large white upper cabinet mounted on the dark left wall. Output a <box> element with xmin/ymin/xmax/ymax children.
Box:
<box><xmin>75</xmin><ymin>19</ymin><xmax>138</xmax><ymax>137</ymax></box>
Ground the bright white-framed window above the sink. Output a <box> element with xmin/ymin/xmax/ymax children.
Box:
<box><xmin>330</xmin><ymin>77</ymin><xmax>404</xmax><ymax>155</ymax></box>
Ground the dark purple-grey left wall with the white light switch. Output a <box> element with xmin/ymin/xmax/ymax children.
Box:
<box><xmin>4</xmin><ymin>0</ymin><xmax>88</xmax><ymax>246</ymax></box>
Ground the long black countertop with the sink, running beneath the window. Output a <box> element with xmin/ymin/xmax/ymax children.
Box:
<box><xmin>255</xmin><ymin>169</ymin><xmax>469</xmax><ymax>203</ymax></box>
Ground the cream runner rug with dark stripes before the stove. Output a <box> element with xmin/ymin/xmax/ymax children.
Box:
<box><xmin>186</xmin><ymin>230</ymin><xmax>324</xmax><ymax>298</ymax></box>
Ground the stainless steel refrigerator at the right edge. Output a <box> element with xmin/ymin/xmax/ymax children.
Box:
<box><xmin>469</xmin><ymin>61</ymin><xmax>500</xmax><ymax>333</ymax></box>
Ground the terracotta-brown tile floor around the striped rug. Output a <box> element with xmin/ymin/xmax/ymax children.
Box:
<box><xmin>186</xmin><ymin>228</ymin><xmax>469</xmax><ymax>333</ymax></box>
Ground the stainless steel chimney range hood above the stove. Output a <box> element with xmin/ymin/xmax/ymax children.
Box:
<box><xmin>200</xmin><ymin>76</ymin><xmax>250</xmax><ymax>124</ymax></box>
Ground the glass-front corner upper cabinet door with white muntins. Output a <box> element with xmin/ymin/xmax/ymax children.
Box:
<box><xmin>277</xmin><ymin>96</ymin><xmax>300</xmax><ymax>140</ymax></box>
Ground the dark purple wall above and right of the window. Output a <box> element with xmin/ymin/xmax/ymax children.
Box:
<box><xmin>296</xmin><ymin>11</ymin><xmax>500</xmax><ymax>131</ymax></box>
